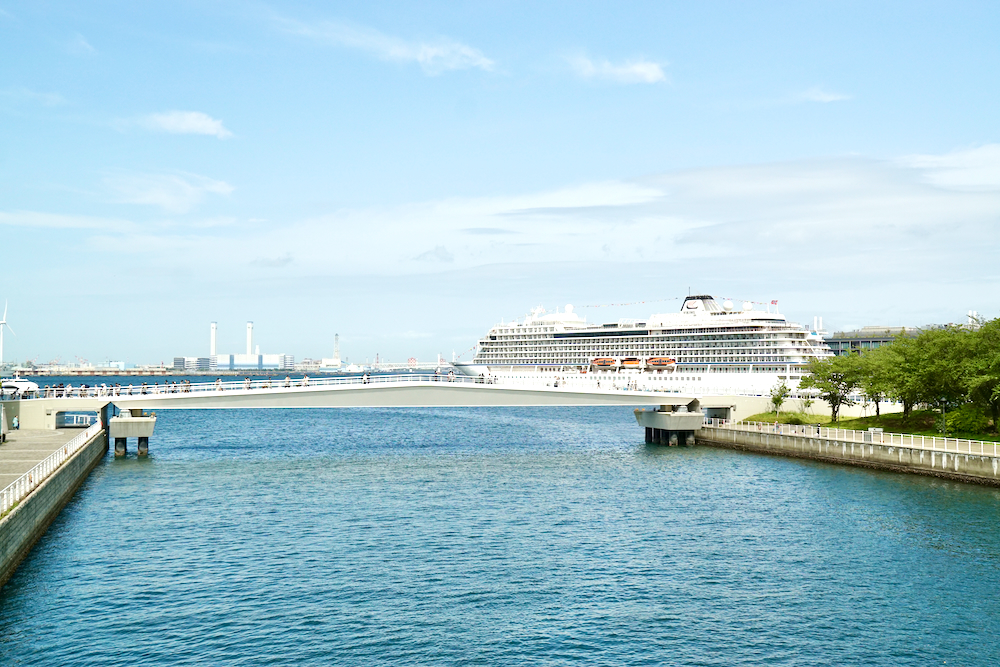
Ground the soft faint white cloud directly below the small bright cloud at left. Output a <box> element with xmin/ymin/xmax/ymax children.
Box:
<box><xmin>104</xmin><ymin>173</ymin><xmax>235</xmax><ymax>213</ymax></box>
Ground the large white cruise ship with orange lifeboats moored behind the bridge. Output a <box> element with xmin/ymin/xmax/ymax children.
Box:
<box><xmin>455</xmin><ymin>295</ymin><xmax>833</xmax><ymax>395</ymax></box>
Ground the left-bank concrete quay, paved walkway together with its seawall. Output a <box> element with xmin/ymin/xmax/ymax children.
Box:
<box><xmin>0</xmin><ymin>429</ymin><xmax>108</xmax><ymax>586</ymax></box>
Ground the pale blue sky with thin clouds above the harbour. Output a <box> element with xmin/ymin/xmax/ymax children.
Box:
<box><xmin>0</xmin><ymin>0</ymin><xmax>1000</xmax><ymax>364</ymax></box>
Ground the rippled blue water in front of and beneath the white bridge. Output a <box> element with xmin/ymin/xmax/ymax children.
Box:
<box><xmin>0</xmin><ymin>408</ymin><xmax>1000</xmax><ymax>665</ymax></box>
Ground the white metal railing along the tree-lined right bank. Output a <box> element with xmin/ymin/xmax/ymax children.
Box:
<box><xmin>705</xmin><ymin>419</ymin><xmax>1000</xmax><ymax>456</ymax></box>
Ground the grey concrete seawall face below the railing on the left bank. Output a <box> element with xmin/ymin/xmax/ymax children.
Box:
<box><xmin>0</xmin><ymin>431</ymin><xmax>108</xmax><ymax>586</ymax></box>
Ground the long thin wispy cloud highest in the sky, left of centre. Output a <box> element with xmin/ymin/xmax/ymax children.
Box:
<box><xmin>279</xmin><ymin>19</ymin><xmax>495</xmax><ymax>75</ymax></box>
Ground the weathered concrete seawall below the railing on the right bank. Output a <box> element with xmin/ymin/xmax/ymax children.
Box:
<box><xmin>695</xmin><ymin>426</ymin><xmax>1000</xmax><ymax>486</ymax></box>
